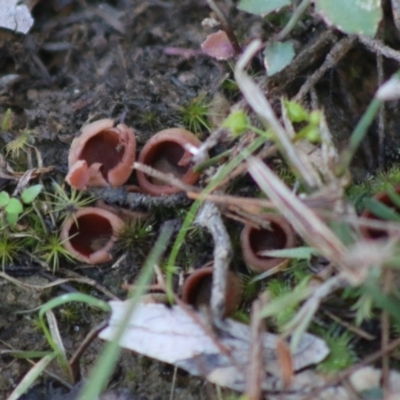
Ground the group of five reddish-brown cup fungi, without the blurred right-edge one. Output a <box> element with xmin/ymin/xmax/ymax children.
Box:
<box><xmin>61</xmin><ymin>119</ymin><xmax>295</xmax><ymax>315</ymax></box>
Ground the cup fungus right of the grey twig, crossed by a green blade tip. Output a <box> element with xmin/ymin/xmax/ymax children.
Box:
<box><xmin>240</xmin><ymin>214</ymin><xmax>296</xmax><ymax>272</ymax></box>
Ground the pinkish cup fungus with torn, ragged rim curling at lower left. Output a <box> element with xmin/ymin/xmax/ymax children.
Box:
<box><xmin>65</xmin><ymin>119</ymin><xmax>136</xmax><ymax>190</ymax></box>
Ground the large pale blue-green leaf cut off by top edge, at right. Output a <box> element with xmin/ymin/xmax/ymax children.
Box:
<box><xmin>315</xmin><ymin>0</ymin><xmax>382</xmax><ymax>36</ymax></box>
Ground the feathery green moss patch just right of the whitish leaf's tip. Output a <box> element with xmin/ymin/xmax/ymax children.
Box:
<box><xmin>317</xmin><ymin>328</ymin><xmax>357</xmax><ymax>375</ymax></box>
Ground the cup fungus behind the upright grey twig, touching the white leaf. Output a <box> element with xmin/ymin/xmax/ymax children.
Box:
<box><xmin>182</xmin><ymin>267</ymin><xmax>242</xmax><ymax>317</ymax></box>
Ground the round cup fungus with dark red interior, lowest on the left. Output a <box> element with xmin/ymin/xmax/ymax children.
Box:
<box><xmin>60</xmin><ymin>207</ymin><xmax>124</xmax><ymax>264</ymax></box>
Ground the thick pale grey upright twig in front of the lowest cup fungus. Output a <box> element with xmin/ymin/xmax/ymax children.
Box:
<box><xmin>195</xmin><ymin>202</ymin><xmax>232</xmax><ymax>326</ymax></box>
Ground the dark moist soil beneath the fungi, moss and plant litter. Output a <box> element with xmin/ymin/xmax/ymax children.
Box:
<box><xmin>0</xmin><ymin>0</ymin><xmax>400</xmax><ymax>400</ymax></box>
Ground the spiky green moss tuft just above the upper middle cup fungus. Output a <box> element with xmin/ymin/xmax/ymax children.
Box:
<box><xmin>181</xmin><ymin>95</ymin><xmax>210</xmax><ymax>133</ymax></box>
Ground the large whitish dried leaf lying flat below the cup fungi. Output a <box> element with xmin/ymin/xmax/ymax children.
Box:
<box><xmin>99</xmin><ymin>301</ymin><xmax>329</xmax><ymax>391</ymax></box>
